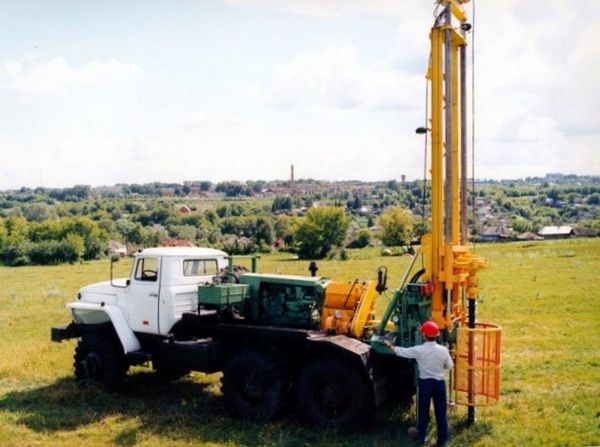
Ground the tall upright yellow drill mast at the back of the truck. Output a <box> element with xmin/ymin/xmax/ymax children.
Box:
<box><xmin>422</xmin><ymin>0</ymin><xmax>485</xmax><ymax>340</ymax></box>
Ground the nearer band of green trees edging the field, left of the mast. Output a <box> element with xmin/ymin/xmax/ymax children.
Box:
<box><xmin>0</xmin><ymin>197</ymin><xmax>413</xmax><ymax>266</ymax></box>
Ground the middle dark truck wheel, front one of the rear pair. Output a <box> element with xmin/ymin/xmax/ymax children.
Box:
<box><xmin>221</xmin><ymin>349</ymin><xmax>286</xmax><ymax>421</ymax></box>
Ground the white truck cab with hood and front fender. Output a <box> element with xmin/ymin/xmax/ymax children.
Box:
<box><xmin>67</xmin><ymin>247</ymin><xmax>228</xmax><ymax>353</ymax></box>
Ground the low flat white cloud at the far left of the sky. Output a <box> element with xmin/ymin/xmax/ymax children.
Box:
<box><xmin>0</xmin><ymin>55</ymin><xmax>141</xmax><ymax>96</ymax></box>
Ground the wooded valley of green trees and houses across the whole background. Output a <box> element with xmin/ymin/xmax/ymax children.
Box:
<box><xmin>0</xmin><ymin>176</ymin><xmax>600</xmax><ymax>265</ymax></box>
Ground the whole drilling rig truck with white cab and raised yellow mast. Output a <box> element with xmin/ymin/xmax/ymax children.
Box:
<box><xmin>52</xmin><ymin>0</ymin><xmax>500</xmax><ymax>427</ymax></box>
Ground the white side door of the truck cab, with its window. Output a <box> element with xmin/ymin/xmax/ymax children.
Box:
<box><xmin>123</xmin><ymin>256</ymin><xmax>161</xmax><ymax>334</ymax></box>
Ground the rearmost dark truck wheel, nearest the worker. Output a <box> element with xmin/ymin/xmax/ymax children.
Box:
<box><xmin>296</xmin><ymin>359</ymin><xmax>367</xmax><ymax>428</ymax></box>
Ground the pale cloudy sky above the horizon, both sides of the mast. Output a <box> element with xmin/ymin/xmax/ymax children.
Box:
<box><xmin>0</xmin><ymin>0</ymin><xmax>600</xmax><ymax>189</ymax></box>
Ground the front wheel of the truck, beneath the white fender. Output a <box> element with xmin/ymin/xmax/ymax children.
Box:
<box><xmin>73</xmin><ymin>331</ymin><xmax>128</xmax><ymax>391</ymax></box>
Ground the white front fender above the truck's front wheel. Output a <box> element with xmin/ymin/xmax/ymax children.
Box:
<box><xmin>67</xmin><ymin>303</ymin><xmax>141</xmax><ymax>354</ymax></box>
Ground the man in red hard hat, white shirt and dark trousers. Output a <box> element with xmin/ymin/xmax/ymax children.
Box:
<box><xmin>383</xmin><ymin>321</ymin><xmax>454</xmax><ymax>446</ymax></box>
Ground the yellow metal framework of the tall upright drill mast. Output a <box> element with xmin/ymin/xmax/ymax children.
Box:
<box><xmin>421</xmin><ymin>0</ymin><xmax>487</xmax><ymax>331</ymax></box>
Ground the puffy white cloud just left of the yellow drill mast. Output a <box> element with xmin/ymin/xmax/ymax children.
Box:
<box><xmin>258</xmin><ymin>45</ymin><xmax>424</xmax><ymax>110</ymax></box>
